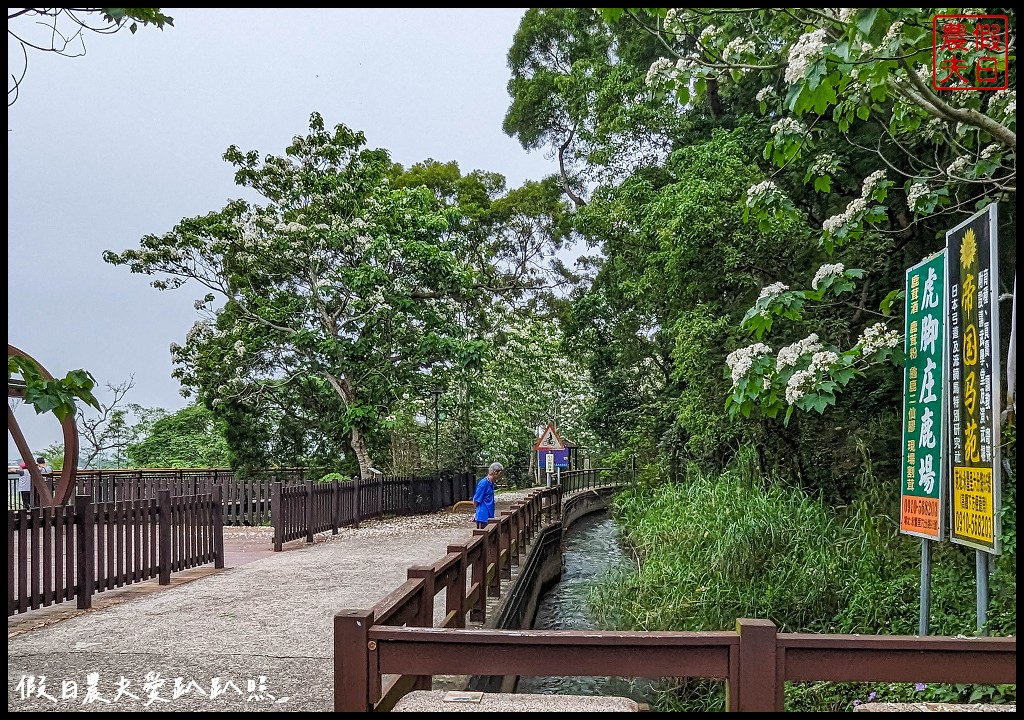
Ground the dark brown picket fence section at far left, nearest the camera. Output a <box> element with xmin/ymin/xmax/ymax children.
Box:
<box><xmin>7</xmin><ymin>485</ymin><xmax>224</xmax><ymax>617</ymax></box>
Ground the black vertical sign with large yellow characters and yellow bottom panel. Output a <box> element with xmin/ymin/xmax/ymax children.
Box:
<box><xmin>946</xmin><ymin>204</ymin><xmax>1000</xmax><ymax>555</ymax></box>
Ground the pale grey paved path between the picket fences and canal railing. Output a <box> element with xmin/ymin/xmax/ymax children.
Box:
<box><xmin>7</xmin><ymin>492</ymin><xmax>526</xmax><ymax>712</ymax></box>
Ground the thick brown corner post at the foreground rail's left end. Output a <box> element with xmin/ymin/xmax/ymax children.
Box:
<box><xmin>334</xmin><ymin>610</ymin><xmax>376</xmax><ymax>713</ymax></box>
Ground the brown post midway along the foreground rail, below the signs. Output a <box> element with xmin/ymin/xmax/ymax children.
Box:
<box><xmin>737</xmin><ymin>618</ymin><xmax>782</xmax><ymax>713</ymax></box>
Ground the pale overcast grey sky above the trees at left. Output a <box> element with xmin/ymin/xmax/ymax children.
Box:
<box><xmin>7</xmin><ymin>8</ymin><xmax>556</xmax><ymax>458</ymax></box>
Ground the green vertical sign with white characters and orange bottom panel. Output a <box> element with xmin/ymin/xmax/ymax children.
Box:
<box><xmin>899</xmin><ymin>251</ymin><xmax>949</xmax><ymax>540</ymax></box>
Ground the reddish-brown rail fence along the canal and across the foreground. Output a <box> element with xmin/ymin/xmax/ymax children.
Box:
<box><xmin>334</xmin><ymin>481</ymin><xmax>1017</xmax><ymax>712</ymax></box>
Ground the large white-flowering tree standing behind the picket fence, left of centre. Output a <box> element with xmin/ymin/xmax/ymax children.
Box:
<box><xmin>104</xmin><ymin>114</ymin><xmax>577</xmax><ymax>476</ymax></box>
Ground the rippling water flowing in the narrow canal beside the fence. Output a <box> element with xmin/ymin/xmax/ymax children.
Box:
<box><xmin>516</xmin><ymin>513</ymin><xmax>667</xmax><ymax>705</ymax></box>
